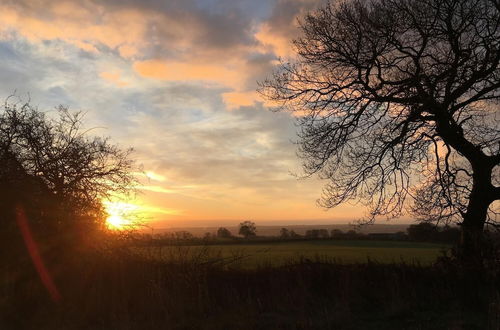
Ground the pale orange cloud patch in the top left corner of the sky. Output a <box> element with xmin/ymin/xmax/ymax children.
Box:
<box><xmin>0</xmin><ymin>2</ymin><xmax>147</xmax><ymax>57</ymax></box>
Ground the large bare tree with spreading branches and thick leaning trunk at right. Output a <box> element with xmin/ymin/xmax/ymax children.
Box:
<box><xmin>261</xmin><ymin>0</ymin><xmax>500</xmax><ymax>257</ymax></box>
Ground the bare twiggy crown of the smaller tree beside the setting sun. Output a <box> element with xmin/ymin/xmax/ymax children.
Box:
<box><xmin>0</xmin><ymin>101</ymin><xmax>136</xmax><ymax>238</ymax></box>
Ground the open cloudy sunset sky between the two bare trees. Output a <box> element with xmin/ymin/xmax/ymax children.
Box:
<box><xmin>0</xmin><ymin>0</ymin><xmax>380</xmax><ymax>227</ymax></box>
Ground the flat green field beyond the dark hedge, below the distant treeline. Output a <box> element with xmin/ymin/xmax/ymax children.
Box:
<box><xmin>141</xmin><ymin>240</ymin><xmax>449</xmax><ymax>268</ymax></box>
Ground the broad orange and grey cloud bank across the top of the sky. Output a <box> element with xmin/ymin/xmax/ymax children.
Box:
<box><xmin>0</xmin><ymin>0</ymin><xmax>322</xmax><ymax>110</ymax></box>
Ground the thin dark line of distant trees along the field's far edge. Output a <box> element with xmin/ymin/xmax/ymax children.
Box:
<box><xmin>130</xmin><ymin>222</ymin><xmax>460</xmax><ymax>244</ymax></box>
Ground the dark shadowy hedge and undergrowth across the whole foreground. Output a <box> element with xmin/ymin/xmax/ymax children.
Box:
<box><xmin>0</xmin><ymin>240</ymin><xmax>500</xmax><ymax>329</ymax></box>
